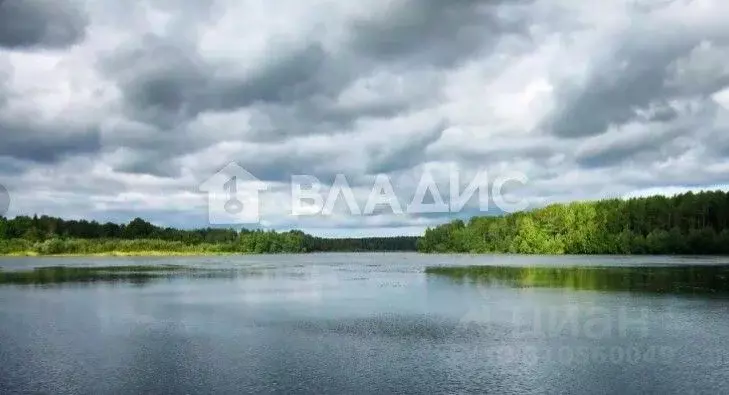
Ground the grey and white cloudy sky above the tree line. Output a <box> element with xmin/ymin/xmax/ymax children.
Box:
<box><xmin>0</xmin><ymin>0</ymin><xmax>729</xmax><ymax>235</ymax></box>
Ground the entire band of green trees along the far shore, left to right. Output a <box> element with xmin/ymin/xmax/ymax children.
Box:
<box><xmin>0</xmin><ymin>191</ymin><xmax>729</xmax><ymax>256</ymax></box>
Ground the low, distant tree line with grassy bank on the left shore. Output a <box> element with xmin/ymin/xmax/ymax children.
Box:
<box><xmin>0</xmin><ymin>216</ymin><xmax>417</xmax><ymax>255</ymax></box>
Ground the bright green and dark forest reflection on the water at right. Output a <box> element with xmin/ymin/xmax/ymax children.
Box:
<box><xmin>425</xmin><ymin>265</ymin><xmax>729</xmax><ymax>295</ymax></box>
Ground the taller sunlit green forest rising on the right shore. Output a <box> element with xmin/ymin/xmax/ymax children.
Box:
<box><xmin>418</xmin><ymin>191</ymin><xmax>729</xmax><ymax>254</ymax></box>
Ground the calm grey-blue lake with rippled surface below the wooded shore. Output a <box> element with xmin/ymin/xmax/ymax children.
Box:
<box><xmin>0</xmin><ymin>253</ymin><xmax>729</xmax><ymax>394</ymax></box>
